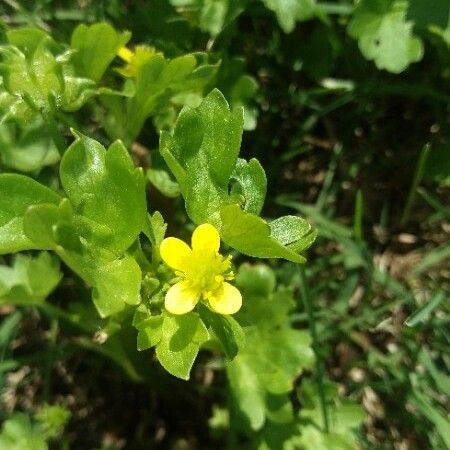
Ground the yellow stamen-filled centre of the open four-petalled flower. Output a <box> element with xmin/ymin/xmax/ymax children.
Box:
<box><xmin>184</xmin><ymin>249</ymin><xmax>234</xmax><ymax>297</ymax></box>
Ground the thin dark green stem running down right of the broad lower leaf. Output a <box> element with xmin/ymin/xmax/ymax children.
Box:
<box><xmin>298</xmin><ymin>265</ymin><xmax>330</xmax><ymax>433</ymax></box>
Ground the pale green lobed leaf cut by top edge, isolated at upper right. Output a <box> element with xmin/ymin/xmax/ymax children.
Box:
<box><xmin>348</xmin><ymin>0</ymin><xmax>423</xmax><ymax>73</ymax></box>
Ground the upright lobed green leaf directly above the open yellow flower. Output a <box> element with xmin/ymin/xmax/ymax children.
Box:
<box><xmin>160</xmin><ymin>90</ymin><xmax>243</xmax><ymax>225</ymax></box>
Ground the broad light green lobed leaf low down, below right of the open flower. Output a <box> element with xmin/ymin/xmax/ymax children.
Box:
<box><xmin>226</xmin><ymin>276</ymin><xmax>314</xmax><ymax>430</ymax></box>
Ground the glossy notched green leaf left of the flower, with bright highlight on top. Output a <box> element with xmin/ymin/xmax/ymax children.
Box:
<box><xmin>60</xmin><ymin>134</ymin><xmax>147</xmax><ymax>254</ymax></box>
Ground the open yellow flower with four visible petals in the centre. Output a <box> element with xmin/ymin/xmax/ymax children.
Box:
<box><xmin>159</xmin><ymin>223</ymin><xmax>242</xmax><ymax>314</ymax></box>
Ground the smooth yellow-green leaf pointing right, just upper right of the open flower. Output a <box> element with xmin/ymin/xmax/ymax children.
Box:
<box><xmin>220</xmin><ymin>205</ymin><xmax>306</xmax><ymax>263</ymax></box>
